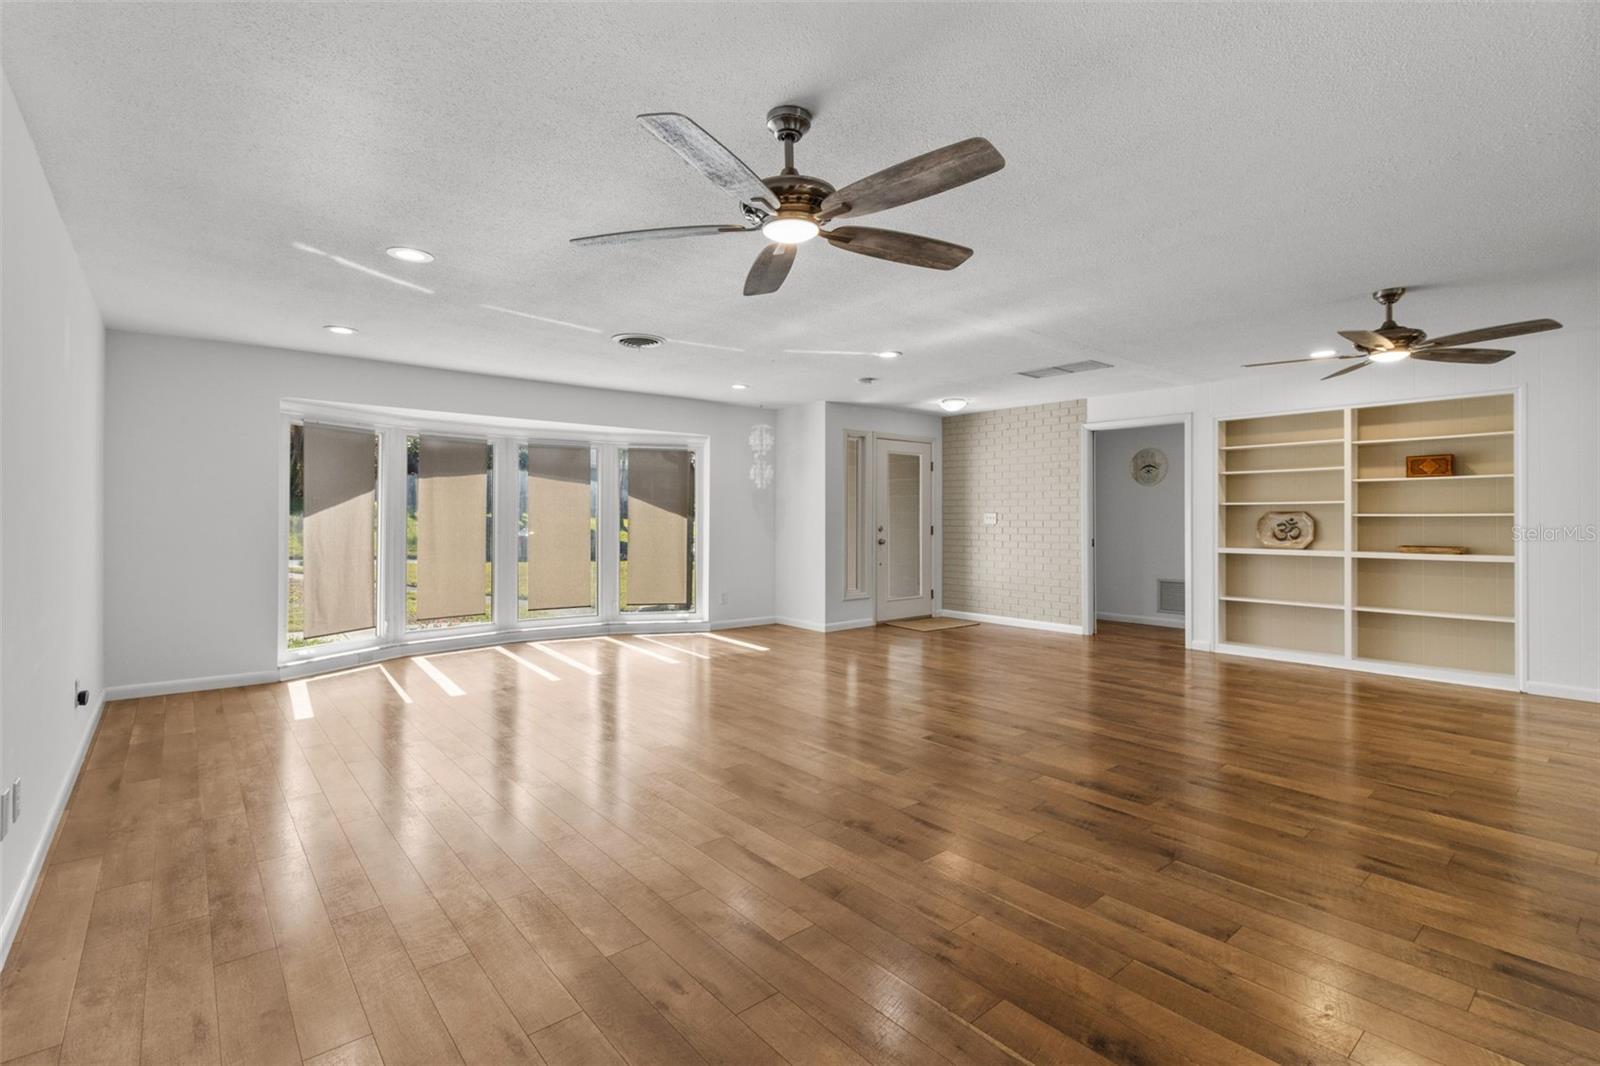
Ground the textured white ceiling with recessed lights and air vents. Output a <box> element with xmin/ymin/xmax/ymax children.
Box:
<box><xmin>0</xmin><ymin>3</ymin><xmax>1600</xmax><ymax>407</ymax></box>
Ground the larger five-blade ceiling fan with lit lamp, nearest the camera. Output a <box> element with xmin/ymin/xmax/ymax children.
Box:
<box><xmin>573</xmin><ymin>104</ymin><xmax>1005</xmax><ymax>296</ymax></box>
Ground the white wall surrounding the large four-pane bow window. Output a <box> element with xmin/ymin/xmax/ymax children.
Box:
<box><xmin>106</xmin><ymin>330</ymin><xmax>774</xmax><ymax>687</ymax></box>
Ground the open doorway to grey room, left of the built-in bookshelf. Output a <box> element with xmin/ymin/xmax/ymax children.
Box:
<box><xmin>1083</xmin><ymin>419</ymin><xmax>1190</xmax><ymax>642</ymax></box>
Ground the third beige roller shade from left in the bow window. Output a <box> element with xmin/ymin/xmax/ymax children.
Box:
<box><xmin>528</xmin><ymin>445</ymin><xmax>594</xmax><ymax>611</ymax></box>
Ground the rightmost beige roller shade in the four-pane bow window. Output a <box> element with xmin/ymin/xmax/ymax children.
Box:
<box><xmin>627</xmin><ymin>448</ymin><xmax>694</xmax><ymax>607</ymax></box>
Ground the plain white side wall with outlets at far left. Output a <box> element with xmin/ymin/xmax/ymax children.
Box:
<box><xmin>0</xmin><ymin>77</ymin><xmax>104</xmax><ymax>957</ymax></box>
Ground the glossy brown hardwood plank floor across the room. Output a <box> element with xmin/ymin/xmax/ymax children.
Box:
<box><xmin>0</xmin><ymin>624</ymin><xmax>1600</xmax><ymax>1066</ymax></box>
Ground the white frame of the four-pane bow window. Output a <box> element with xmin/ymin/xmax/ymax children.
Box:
<box><xmin>275</xmin><ymin>400</ymin><xmax>710</xmax><ymax>665</ymax></box>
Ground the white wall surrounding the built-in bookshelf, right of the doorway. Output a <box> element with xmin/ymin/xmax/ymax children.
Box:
<box><xmin>1090</xmin><ymin>282</ymin><xmax>1600</xmax><ymax>699</ymax></box>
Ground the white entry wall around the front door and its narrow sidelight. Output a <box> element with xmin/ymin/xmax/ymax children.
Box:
<box><xmin>822</xmin><ymin>403</ymin><xmax>944</xmax><ymax>629</ymax></box>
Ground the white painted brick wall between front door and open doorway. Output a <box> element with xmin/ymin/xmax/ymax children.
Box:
<box><xmin>941</xmin><ymin>400</ymin><xmax>1088</xmax><ymax>626</ymax></box>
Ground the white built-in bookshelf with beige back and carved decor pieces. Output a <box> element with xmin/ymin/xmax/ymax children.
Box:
<box><xmin>1216</xmin><ymin>394</ymin><xmax>1517</xmax><ymax>683</ymax></box>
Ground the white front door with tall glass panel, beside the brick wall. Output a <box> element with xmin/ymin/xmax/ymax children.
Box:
<box><xmin>874</xmin><ymin>437</ymin><xmax>933</xmax><ymax>621</ymax></box>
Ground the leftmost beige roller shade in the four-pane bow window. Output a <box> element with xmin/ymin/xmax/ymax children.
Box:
<box><xmin>301</xmin><ymin>424</ymin><xmax>378</xmax><ymax>637</ymax></box>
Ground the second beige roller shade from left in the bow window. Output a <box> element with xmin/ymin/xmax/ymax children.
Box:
<box><xmin>416</xmin><ymin>437</ymin><xmax>488</xmax><ymax>621</ymax></box>
